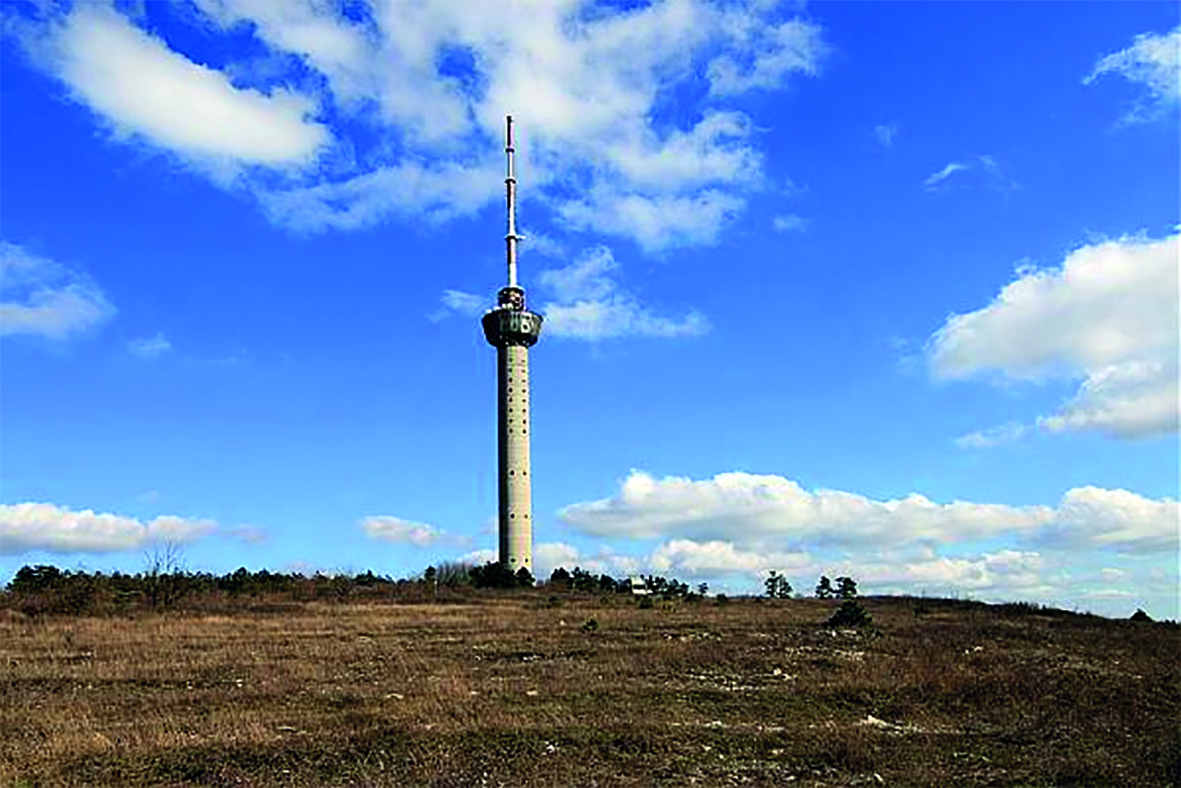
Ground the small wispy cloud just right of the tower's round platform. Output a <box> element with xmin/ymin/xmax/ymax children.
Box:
<box><xmin>537</xmin><ymin>247</ymin><xmax>710</xmax><ymax>341</ymax></box>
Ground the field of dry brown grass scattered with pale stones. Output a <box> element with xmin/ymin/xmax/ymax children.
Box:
<box><xmin>0</xmin><ymin>593</ymin><xmax>1181</xmax><ymax>786</ymax></box>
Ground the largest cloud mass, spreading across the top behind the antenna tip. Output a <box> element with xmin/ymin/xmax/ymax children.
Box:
<box><xmin>4</xmin><ymin>0</ymin><xmax>827</xmax><ymax>252</ymax></box>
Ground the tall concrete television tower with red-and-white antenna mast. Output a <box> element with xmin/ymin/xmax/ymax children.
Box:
<box><xmin>481</xmin><ymin>115</ymin><xmax>542</xmax><ymax>573</ymax></box>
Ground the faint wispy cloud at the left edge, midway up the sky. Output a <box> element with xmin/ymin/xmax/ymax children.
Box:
<box><xmin>0</xmin><ymin>241</ymin><xmax>115</xmax><ymax>339</ymax></box>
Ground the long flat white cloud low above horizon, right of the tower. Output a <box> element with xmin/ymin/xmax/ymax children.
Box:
<box><xmin>560</xmin><ymin>471</ymin><xmax>1179</xmax><ymax>552</ymax></box>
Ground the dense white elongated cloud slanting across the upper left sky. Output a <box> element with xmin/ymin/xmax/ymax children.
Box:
<box><xmin>34</xmin><ymin>4</ymin><xmax>329</xmax><ymax>170</ymax></box>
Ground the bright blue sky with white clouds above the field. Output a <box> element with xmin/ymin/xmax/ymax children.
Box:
<box><xmin>0</xmin><ymin>0</ymin><xmax>1181</xmax><ymax>618</ymax></box>
